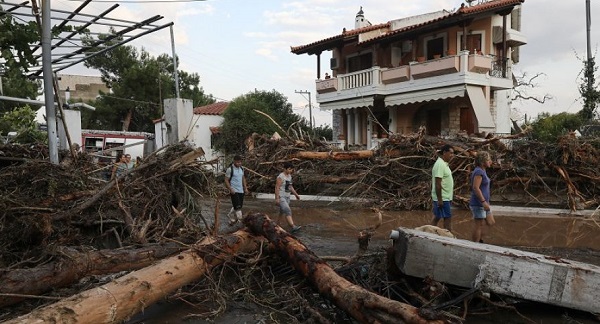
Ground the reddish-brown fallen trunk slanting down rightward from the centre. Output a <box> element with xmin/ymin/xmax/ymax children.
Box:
<box><xmin>244</xmin><ymin>213</ymin><xmax>444</xmax><ymax>324</ymax></box>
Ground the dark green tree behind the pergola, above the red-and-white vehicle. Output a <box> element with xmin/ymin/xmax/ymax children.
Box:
<box><xmin>82</xmin><ymin>30</ymin><xmax>215</xmax><ymax>132</ymax></box>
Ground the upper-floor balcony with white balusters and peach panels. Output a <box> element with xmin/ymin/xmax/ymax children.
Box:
<box><xmin>316</xmin><ymin>51</ymin><xmax>513</xmax><ymax>109</ymax></box>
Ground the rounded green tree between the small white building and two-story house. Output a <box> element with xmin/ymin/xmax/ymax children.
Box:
<box><xmin>215</xmin><ymin>90</ymin><xmax>308</xmax><ymax>154</ymax></box>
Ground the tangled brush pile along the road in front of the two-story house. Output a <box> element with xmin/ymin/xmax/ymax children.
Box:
<box><xmin>245</xmin><ymin>129</ymin><xmax>600</xmax><ymax>210</ymax></box>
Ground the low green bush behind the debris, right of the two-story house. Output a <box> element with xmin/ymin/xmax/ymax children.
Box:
<box><xmin>531</xmin><ymin>112</ymin><xmax>583</xmax><ymax>143</ymax></box>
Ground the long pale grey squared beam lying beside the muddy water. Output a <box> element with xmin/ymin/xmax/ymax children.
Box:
<box><xmin>392</xmin><ymin>228</ymin><xmax>600</xmax><ymax>312</ymax></box>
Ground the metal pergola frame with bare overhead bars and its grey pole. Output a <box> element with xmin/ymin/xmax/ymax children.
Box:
<box><xmin>0</xmin><ymin>0</ymin><xmax>179</xmax><ymax>164</ymax></box>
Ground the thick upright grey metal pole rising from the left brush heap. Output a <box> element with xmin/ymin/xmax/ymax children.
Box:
<box><xmin>42</xmin><ymin>0</ymin><xmax>59</xmax><ymax>164</ymax></box>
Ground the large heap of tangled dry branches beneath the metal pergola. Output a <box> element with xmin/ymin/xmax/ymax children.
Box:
<box><xmin>0</xmin><ymin>145</ymin><xmax>218</xmax><ymax>267</ymax></box>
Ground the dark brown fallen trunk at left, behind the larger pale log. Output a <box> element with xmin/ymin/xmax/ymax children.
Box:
<box><xmin>0</xmin><ymin>243</ymin><xmax>183</xmax><ymax>307</ymax></box>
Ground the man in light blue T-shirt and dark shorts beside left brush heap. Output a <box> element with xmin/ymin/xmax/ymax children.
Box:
<box><xmin>225</xmin><ymin>155</ymin><xmax>248</xmax><ymax>225</ymax></box>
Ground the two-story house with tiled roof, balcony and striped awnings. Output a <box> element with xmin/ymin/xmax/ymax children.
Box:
<box><xmin>291</xmin><ymin>0</ymin><xmax>526</xmax><ymax>147</ymax></box>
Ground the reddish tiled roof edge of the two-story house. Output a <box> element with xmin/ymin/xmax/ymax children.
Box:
<box><xmin>291</xmin><ymin>0</ymin><xmax>525</xmax><ymax>54</ymax></box>
